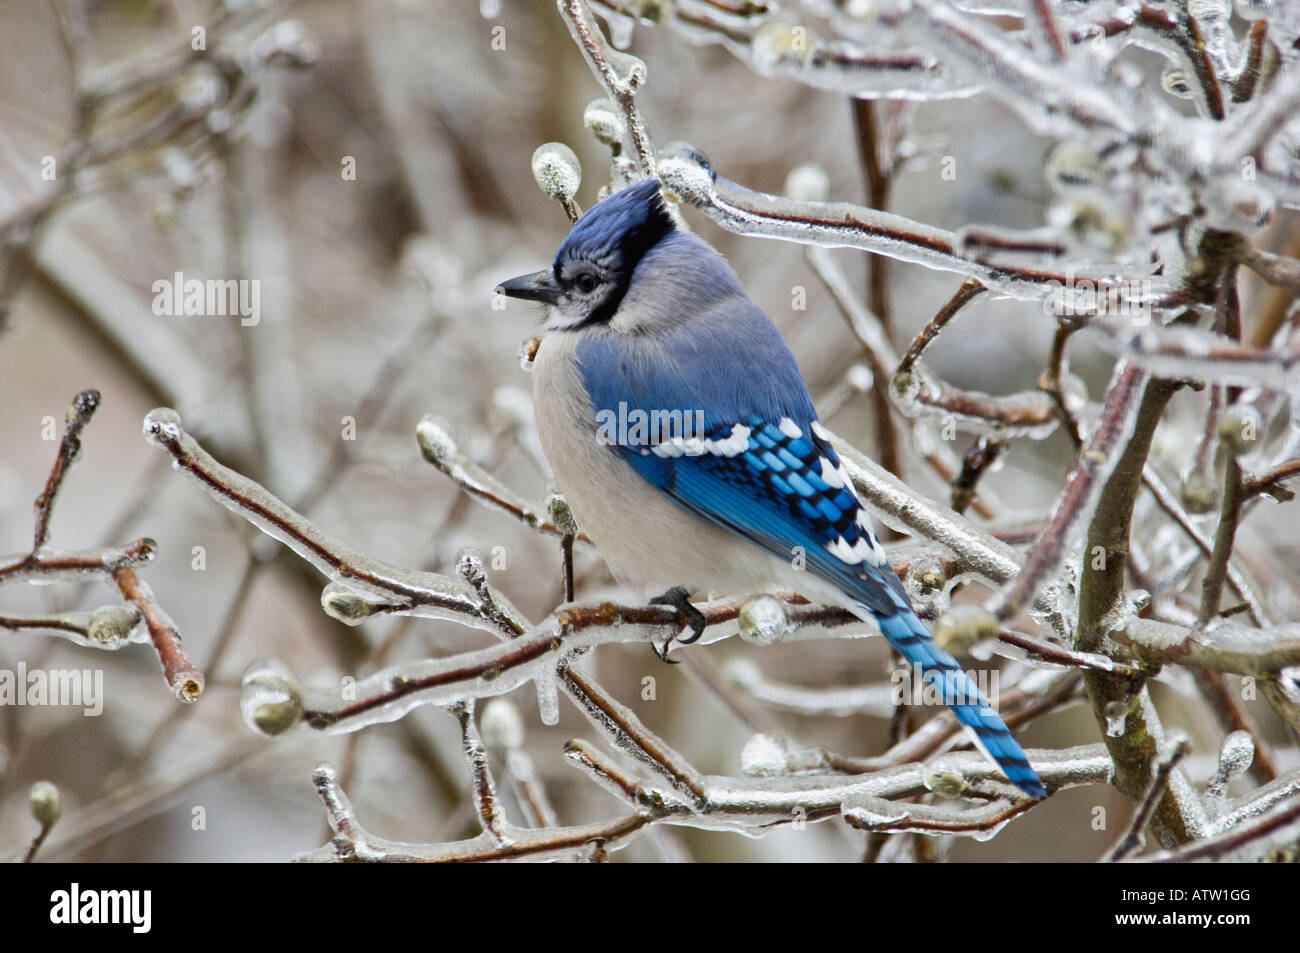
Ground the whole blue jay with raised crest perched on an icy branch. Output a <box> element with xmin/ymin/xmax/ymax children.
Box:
<box><xmin>498</xmin><ymin>178</ymin><xmax>1047</xmax><ymax>797</ymax></box>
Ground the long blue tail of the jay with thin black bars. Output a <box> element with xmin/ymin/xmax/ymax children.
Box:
<box><xmin>876</xmin><ymin>610</ymin><xmax>1048</xmax><ymax>798</ymax></box>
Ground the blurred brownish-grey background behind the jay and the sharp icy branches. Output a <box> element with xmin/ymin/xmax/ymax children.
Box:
<box><xmin>0</xmin><ymin>0</ymin><xmax>1297</xmax><ymax>861</ymax></box>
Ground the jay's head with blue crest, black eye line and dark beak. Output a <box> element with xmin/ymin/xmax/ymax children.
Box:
<box><xmin>498</xmin><ymin>178</ymin><xmax>676</xmax><ymax>330</ymax></box>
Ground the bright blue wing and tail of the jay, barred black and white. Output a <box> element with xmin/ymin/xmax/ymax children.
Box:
<box><xmin>577</xmin><ymin>319</ymin><xmax>1047</xmax><ymax>797</ymax></box>
